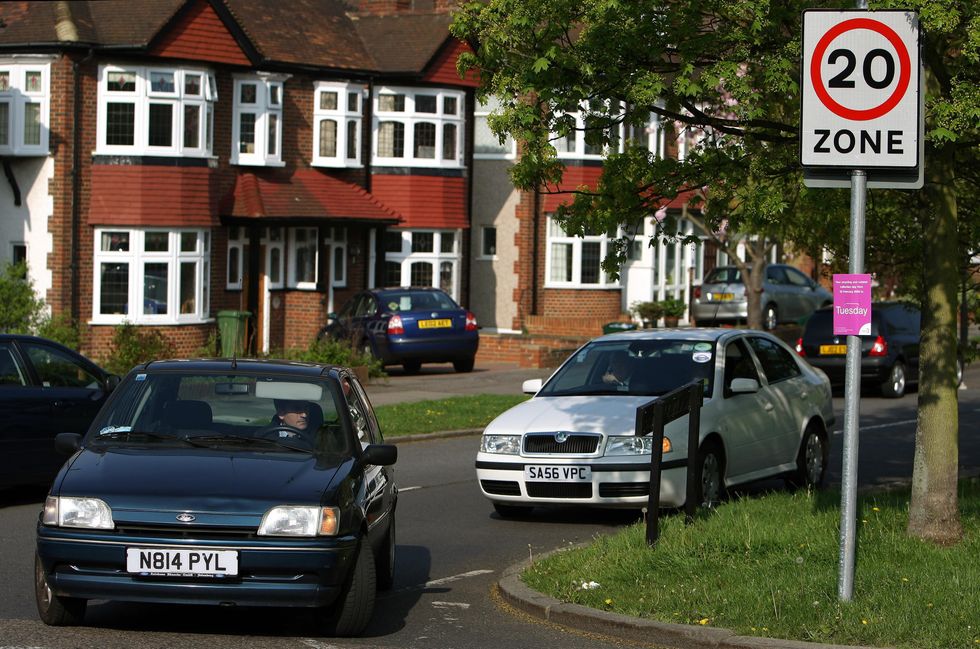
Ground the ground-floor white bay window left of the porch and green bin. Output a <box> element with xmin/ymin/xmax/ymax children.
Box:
<box><xmin>92</xmin><ymin>228</ymin><xmax>210</xmax><ymax>324</ymax></box>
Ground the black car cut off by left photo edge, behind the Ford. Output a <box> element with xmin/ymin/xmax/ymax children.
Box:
<box><xmin>0</xmin><ymin>334</ymin><xmax>119</xmax><ymax>487</ymax></box>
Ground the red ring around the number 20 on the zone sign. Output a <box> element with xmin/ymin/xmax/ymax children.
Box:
<box><xmin>810</xmin><ymin>18</ymin><xmax>912</xmax><ymax>121</ymax></box>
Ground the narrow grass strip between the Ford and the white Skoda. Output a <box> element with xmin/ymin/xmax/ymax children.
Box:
<box><xmin>374</xmin><ymin>394</ymin><xmax>529</xmax><ymax>437</ymax></box>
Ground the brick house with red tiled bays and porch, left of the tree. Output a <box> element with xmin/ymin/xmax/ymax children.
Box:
<box><xmin>0</xmin><ymin>0</ymin><xmax>475</xmax><ymax>358</ymax></box>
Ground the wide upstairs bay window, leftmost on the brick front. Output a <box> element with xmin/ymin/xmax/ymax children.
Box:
<box><xmin>96</xmin><ymin>65</ymin><xmax>218</xmax><ymax>157</ymax></box>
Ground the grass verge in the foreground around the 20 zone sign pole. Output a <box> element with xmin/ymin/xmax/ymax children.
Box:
<box><xmin>523</xmin><ymin>479</ymin><xmax>980</xmax><ymax>649</ymax></box>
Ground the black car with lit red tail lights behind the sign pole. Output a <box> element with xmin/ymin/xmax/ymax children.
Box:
<box><xmin>796</xmin><ymin>302</ymin><xmax>920</xmax><ymax>398</ymax></box>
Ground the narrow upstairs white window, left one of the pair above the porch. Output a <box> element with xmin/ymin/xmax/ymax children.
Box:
<box><xmin>229</xmin><ymin>74</ymin><xmax>288</xmax><ymax>167</ymax></box>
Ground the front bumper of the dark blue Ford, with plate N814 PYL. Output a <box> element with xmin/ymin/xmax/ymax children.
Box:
<box><xmin>37</xmin><ymin>524</ymin><xmax>357</xmax><ymax>607</ymax></box>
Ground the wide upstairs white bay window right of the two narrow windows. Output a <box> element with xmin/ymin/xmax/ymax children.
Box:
<box><xmin>372</xmin><ymin>86</ymin><xmax>466</xmax><ymax>169</ymax></box>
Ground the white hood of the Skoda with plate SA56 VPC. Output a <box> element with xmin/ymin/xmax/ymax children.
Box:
<box><xmin>485</xmin><ymin>395</ymin><xmax>653</xmax><ymax>435</ymax></box>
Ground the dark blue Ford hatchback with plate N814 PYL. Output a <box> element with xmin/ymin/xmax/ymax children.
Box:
<box><xmin>35</xmin><ymin>359</ymin><xmax>397</xmax><ymax>635</ymax></box>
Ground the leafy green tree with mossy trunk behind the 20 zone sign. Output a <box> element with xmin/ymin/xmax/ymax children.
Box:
<box><xmin>452</xmin><ymin>0</ymin><xmax>980</xmax><ymax>543</ymax></box>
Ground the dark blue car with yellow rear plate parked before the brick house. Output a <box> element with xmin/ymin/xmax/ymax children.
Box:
<box><xmin>320</xmin><ymin>288</ymin><xmax>480</xmax><ymax>374</ymax></box>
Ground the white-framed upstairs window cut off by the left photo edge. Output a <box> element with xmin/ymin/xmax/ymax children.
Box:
<box><xmin>0</xmin><ymin>57</ymin><xmax>51</xmax><ymax>156</ymax></box>
